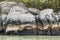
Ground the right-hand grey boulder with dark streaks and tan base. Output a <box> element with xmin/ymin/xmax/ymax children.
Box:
<box><xmin>38</xmin><ymin>9</ymin><xmax>54</xmax><ymax>30</ymax></box>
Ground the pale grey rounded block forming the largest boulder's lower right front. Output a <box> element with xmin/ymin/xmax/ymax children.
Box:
<box><xmin>20</xmin><ymin>13</ymin><xmax>35</xmax><ymax>23</ymax></box>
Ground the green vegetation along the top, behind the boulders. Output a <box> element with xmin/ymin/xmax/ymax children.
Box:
<box><xmin>0</xmin><ymin>0</ymin><xmax>60</xmax><ymax>11</ymax></box>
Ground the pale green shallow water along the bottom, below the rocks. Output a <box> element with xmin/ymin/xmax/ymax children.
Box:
<box><xmin>0</xmin><ymin>35</ymin><xmax>60</xmax><ymax>40</ymax></box>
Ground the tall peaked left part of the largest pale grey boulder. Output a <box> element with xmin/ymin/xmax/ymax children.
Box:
<box><xmin>4</xmin><ymin>6</ymin><xmax>27</xmax><ymax>21</ymax></box>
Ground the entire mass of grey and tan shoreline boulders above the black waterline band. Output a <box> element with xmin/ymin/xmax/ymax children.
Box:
<box><xmin>0</xmin><ymin>1</ymin><xmax>60</xmax><ymax>35</ymax></box>
